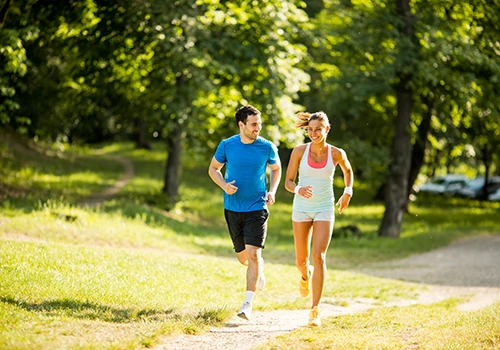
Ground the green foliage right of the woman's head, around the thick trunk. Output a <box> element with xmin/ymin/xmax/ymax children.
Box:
<box><xmin>301</xmin><ymin>0</ymin><xmax>500</xmax><ymax>183</ymax></box>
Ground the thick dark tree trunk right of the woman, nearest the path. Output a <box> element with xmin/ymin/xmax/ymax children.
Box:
<box><xmin>378</xmin><ymin>0</ymin><xmax>414</xmax><ymax>238</ymax></box>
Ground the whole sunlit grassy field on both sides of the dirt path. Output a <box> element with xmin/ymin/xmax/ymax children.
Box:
<box><xmin>0</xmin><ymin>137</ymin><xmax>500</xmax><ymax>349</ymax></box>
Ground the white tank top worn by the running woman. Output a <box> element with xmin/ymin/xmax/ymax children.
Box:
<box><xmin>293</xmin><ymin>143</ymin><xmax>335</xmax><ymax>213</ymax></box>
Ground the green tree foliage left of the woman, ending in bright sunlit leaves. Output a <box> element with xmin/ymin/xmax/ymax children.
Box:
<box><xmin>2</xmin><ymin>0</ymin><xmax>308</xmax><ymax>151</ymax></box>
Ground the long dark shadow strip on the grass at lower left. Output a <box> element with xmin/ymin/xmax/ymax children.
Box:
<box><xmin>0</xmin><ymin>297</ymin><xmax>175</xmax><ymax>323</ymax></box>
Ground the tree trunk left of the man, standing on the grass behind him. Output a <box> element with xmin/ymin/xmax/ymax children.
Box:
<box><xmin>163</xmin><ymin>123</ymin><xmax>183</xmax><ymax>210</ymax></box>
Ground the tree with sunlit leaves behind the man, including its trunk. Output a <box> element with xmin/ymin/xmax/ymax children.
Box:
<box><xmin>144</xmin><ymin>0</ymin><xmax>308</xmax><ymax>206</ymax></box>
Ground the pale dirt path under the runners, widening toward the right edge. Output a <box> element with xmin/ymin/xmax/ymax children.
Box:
<box><xmin>155</xmin><ymin>236</ymin><xmax>500</xmax><ymax>350</ymax></box>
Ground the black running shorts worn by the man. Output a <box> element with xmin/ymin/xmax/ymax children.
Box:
<box><xmin>224</xmin><ymin>209</ymin><xmax>269</xmax><ymax>253</ymax></box>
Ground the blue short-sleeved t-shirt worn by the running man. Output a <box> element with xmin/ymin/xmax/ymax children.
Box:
<box><xmin>214</xmin><ymin>134</ymin><xmax>279</xmax><ymax>212</ymax></box>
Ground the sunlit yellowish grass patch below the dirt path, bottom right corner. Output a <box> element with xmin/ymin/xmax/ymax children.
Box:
<box><xmin>258</xmin><ymin>299</ymin><xmax>500</xmax><ymax>350</ymax></box>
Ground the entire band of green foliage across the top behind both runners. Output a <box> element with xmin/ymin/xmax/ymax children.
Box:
<box><xmin>0</xmin><ymin>0</ymin><xmax>500</xmax><ymax>193</ymax></box>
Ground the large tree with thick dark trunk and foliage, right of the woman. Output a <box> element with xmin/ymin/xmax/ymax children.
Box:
<box><xmin>304</xmin><ymin>0</ymin><xmax>498</xmax><ymax>237</ymax></box>
